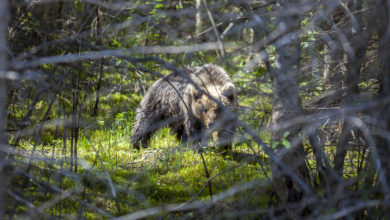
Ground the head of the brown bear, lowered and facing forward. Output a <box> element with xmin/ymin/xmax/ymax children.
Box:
<box><xmin>191</xmin><ymin>83</ymin><xmax>237</xmax><ymax>130</ymax></box>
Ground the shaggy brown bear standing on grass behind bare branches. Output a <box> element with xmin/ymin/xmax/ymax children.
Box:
<box><xmin>131</xmin><ymin>64</ymin><xmax>237</xmax><ymax>153</ymax></box>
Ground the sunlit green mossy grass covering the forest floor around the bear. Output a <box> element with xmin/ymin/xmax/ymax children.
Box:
<box><xmin>8</xmin><ymin>109</ymin><xmax>372</xmax><ymax>219</ymax></box>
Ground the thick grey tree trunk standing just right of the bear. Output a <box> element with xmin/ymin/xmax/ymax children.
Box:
<box><xmin>271</xmin><ymin>2</ymin><xmax>308</xmax><ymax>205</ymax></box>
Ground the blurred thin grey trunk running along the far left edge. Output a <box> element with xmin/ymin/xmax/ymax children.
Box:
<box><xmin>0</xmin><ymin>0</ymin><xmax>9</xmax><ymax>219</ymax></box>
